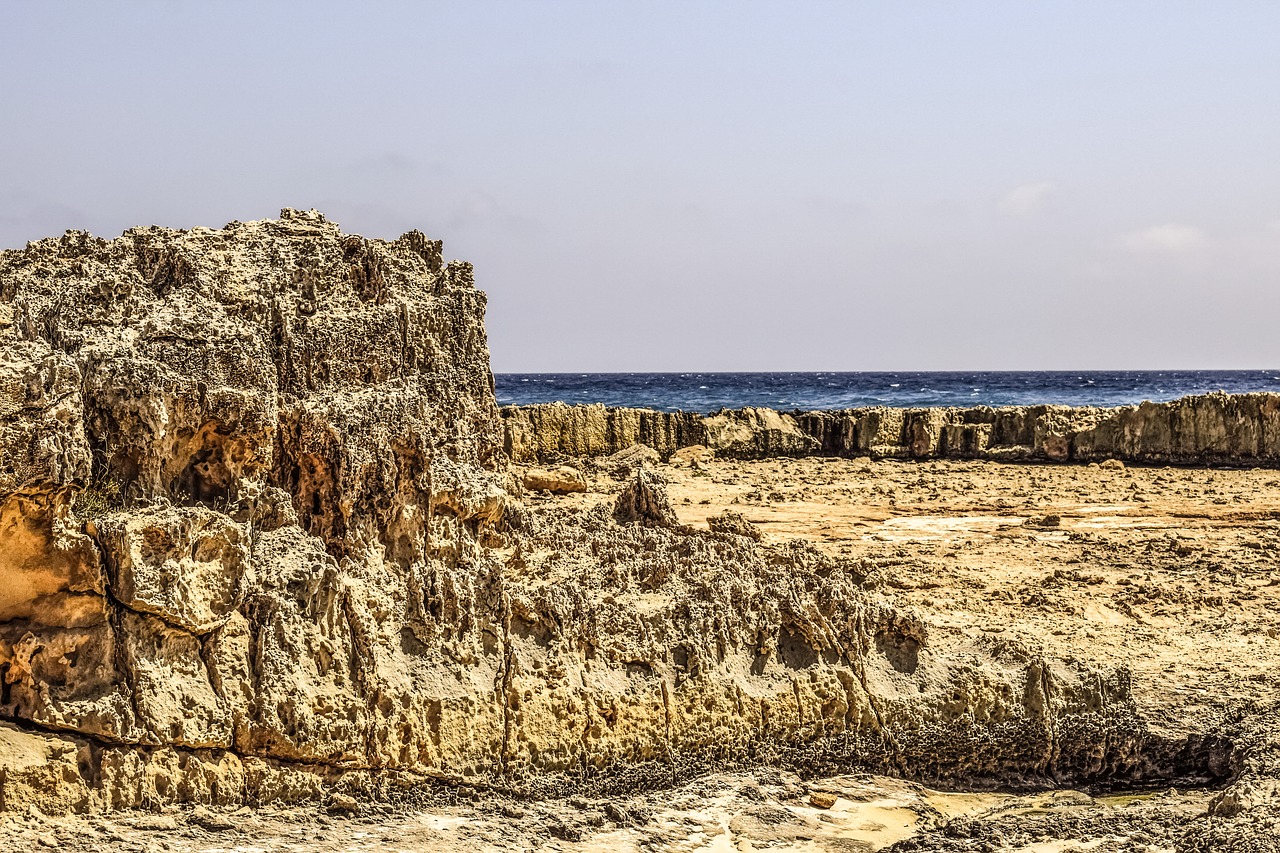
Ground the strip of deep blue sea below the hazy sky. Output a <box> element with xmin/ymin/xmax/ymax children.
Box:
<box><xmin>494</xmin><ymin>370</ymin><xmax>1280</xmax><ymax>412</ymax></box>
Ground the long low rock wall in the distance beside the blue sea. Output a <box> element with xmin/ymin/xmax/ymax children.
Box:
<box><xmin>502</xmin><ymin>393</ymin><xmax>1280</xmax><ymax>465</ymax></box>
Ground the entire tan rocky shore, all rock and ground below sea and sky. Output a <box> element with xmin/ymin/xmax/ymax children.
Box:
<box><xmin>0</xmin><ymin>210</ymin><xmax>1280</xmax><ymax>853</ymax></box>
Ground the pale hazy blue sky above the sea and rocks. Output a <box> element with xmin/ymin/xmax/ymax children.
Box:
<box><xmin>0</xmin><ymin>0</ymin><xmax>1280</xmax><ymax>371</ymax></box>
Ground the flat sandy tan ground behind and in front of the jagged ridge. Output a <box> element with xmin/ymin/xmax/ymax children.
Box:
<box><xmin>12</xmin><ymin>459</ymin><xmax>1280</xmax><ymax>853</ymax></box>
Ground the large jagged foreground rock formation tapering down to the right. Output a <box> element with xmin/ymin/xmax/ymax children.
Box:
<box><xmin>0</xmin><ymin>210</ymin><xmax>1275</xmax><ymax>845</ymax></box>
